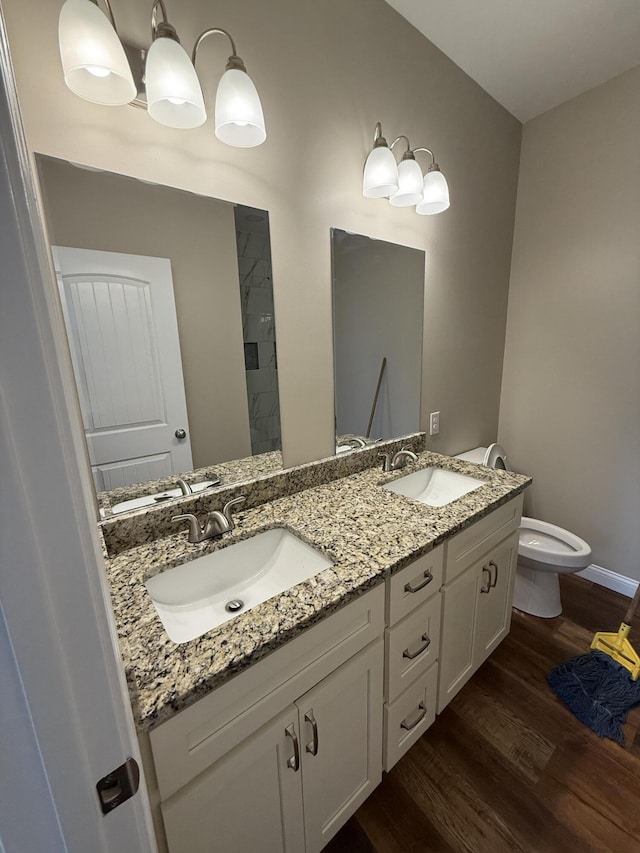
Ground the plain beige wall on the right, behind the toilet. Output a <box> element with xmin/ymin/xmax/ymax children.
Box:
<box><xmin>499</xmin><ymin>68</ymin><xmax>640</xmax><ymax>579</ymax></box>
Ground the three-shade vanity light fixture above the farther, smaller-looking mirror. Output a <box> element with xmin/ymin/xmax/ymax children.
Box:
<box><xmin>362</xmin><ymin>122</ymin><xmax>449</xmax><ymax>216</ymax></box>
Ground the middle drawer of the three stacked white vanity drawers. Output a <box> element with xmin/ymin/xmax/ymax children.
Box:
<box><xmin>385</xmin><ymin>592</ymin><xmax>442</xmax><ymax>702</ymax></box>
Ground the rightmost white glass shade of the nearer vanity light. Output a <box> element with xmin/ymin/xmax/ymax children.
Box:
<box><xmin>215</xmin><ymin>68</ymin><xmax>267</xmax><ymax>148</ymax></box>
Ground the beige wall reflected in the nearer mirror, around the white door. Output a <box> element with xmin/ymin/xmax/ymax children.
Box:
<box><xmin>40</xmin><ymin>158</ymin><xmax>251</xmax><ymax>468</ymax></box>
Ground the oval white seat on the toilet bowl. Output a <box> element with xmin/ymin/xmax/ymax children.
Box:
<box><xmin>518</xmin><ymin>516</ymin><xmax>591</xmax><ymax>572</ymax></box>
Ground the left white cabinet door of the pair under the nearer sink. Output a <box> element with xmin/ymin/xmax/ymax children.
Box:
<box><xmin>162</xmin><ymin>705</ymin><xmax>304</xmax><ymax>853</ymax></box>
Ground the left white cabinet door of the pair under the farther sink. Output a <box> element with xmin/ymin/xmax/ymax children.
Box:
<box><xmin>438</xmin><ymin>563</ymin><xmax>482</xmax><ymax>713</ymax></box>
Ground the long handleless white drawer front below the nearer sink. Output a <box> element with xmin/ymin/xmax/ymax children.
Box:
<box><xmin>150</xmin><ymin>585</ymin><xmax>384</xmax><ymax>800</ymax></box>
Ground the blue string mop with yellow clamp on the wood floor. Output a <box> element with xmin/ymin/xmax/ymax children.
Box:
<box><xmin>547</xmin><ymin>584</ymin><xmax>640</xmax><ymax>746</ymax></box>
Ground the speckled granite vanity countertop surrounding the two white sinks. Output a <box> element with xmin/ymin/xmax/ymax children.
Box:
<box><xmin>107</xmin><ymin>451</ymin><xmax>531</xmax><ymax>731</ymax></box>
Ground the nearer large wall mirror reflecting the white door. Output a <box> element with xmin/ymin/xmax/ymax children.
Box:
<box><xmin>37</xmin><ymin>155</ymin><xmax>282</xmax><ymax>512</ymax></box>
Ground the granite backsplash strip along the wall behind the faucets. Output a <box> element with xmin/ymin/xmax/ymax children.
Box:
<box><xmin>100</xmin><ymin>432</ymin><xmax>425</xmax><ymax>557</ymax></box>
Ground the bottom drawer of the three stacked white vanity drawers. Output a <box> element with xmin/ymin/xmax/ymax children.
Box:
<box><xmin>384</xmin><ymin>663</ymin><xmax>438</xmax><ymax>771</ymax></box>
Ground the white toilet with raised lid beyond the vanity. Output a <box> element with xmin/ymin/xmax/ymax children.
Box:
<box><xmin>456</xmin><ymin>444</ymin><xmax>591</xmax><ymax>619</ymax></box>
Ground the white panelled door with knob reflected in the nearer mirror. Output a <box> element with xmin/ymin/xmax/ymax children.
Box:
<box><xmin>52</xmin><ymin>246</ymin><xmax>193</xmax><ymax>490</ymax></box>
